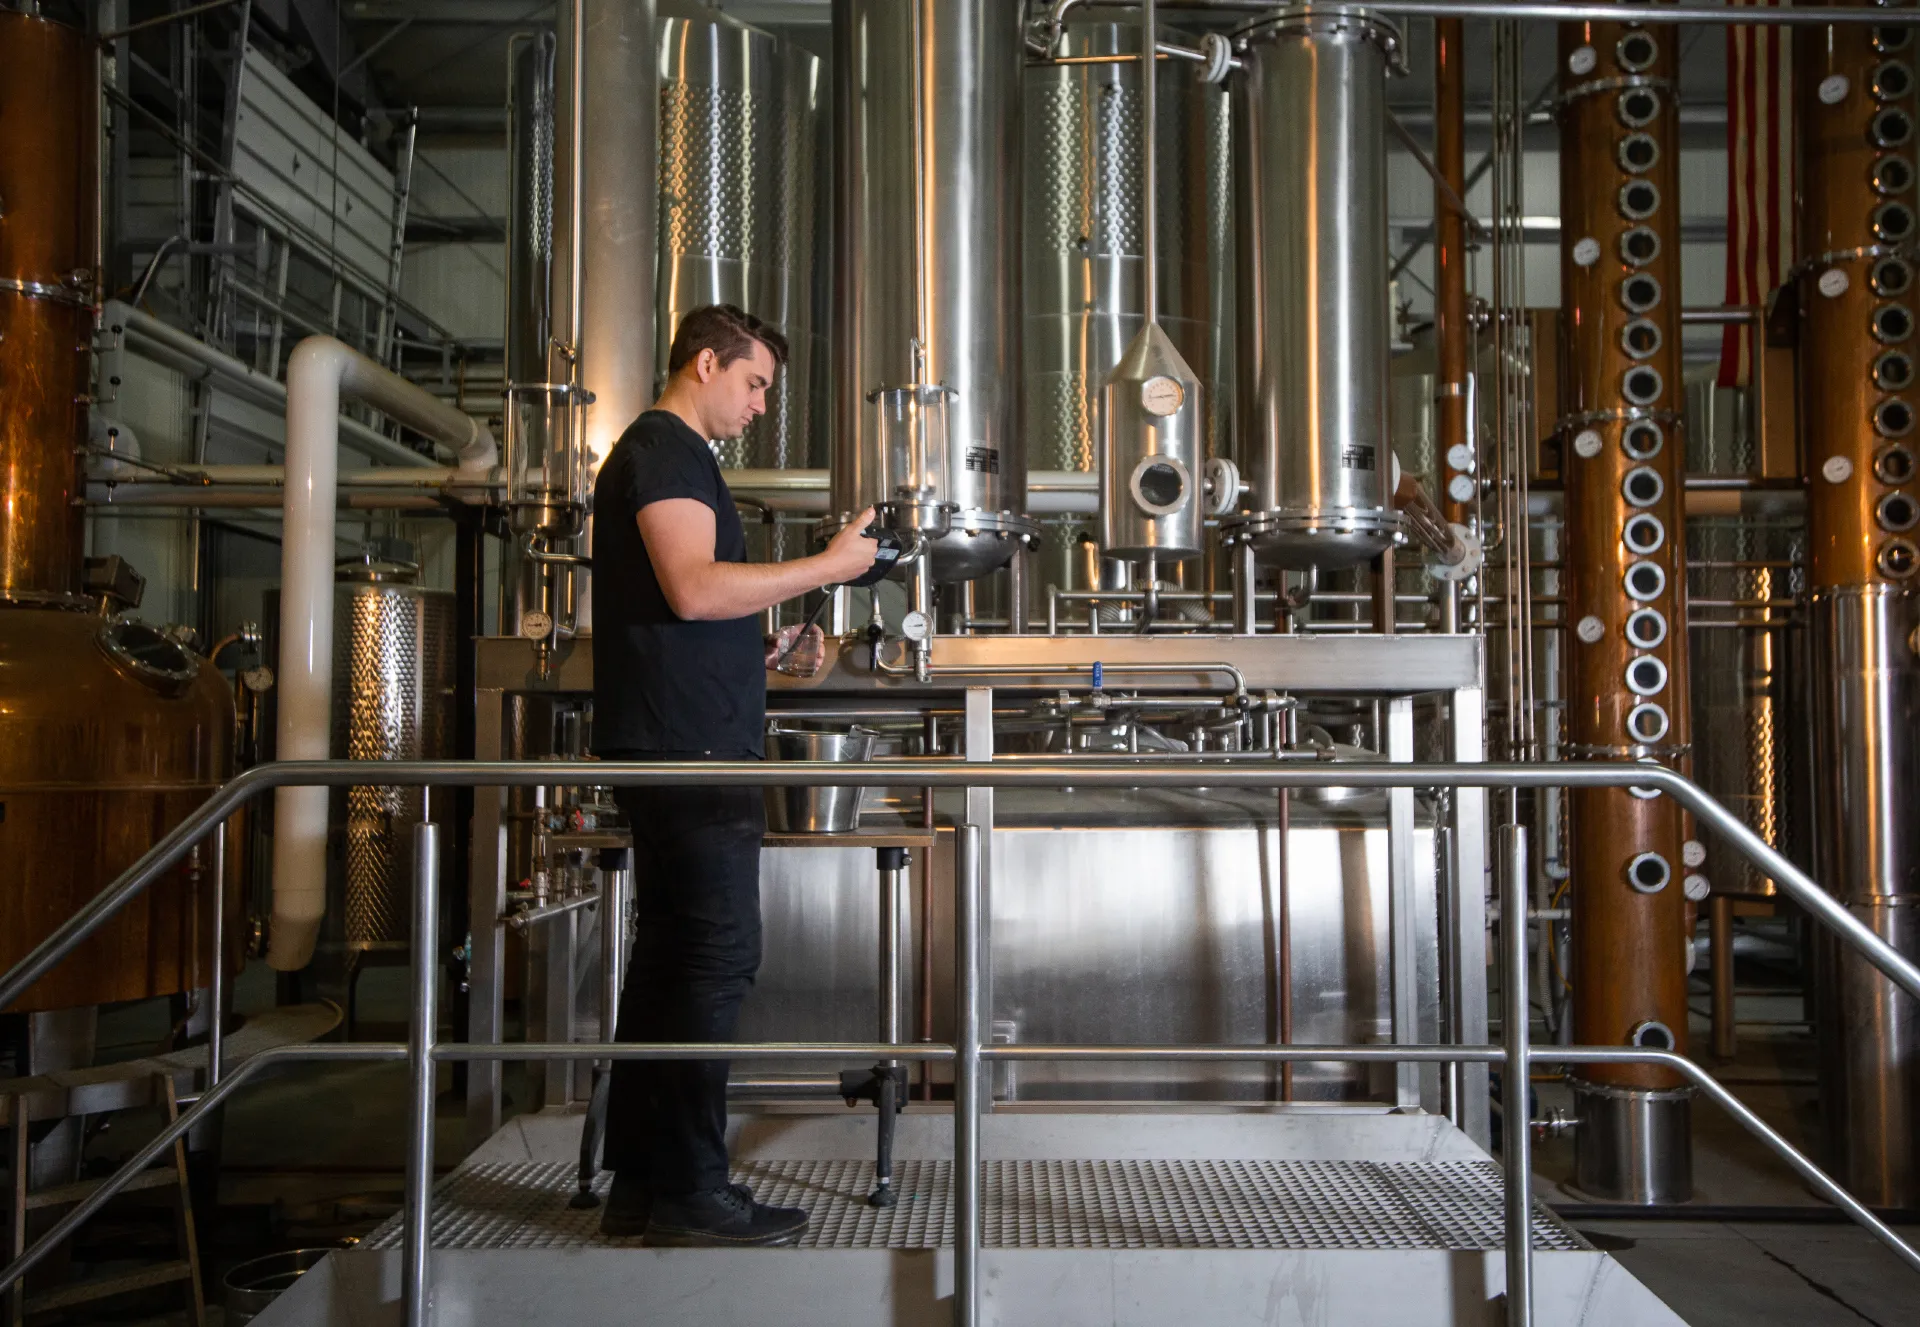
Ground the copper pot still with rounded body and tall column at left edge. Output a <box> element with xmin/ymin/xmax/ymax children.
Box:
<box><xmin>0</xmin><ymin>12</ymin><xmax>238</xmax><ymax>1012</ymax></box>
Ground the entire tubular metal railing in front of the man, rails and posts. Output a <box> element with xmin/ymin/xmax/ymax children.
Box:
<box><xmin>0</xmin><ymin>759</ymin><xmax>1920</xmax><ymax>1327</ymax></box>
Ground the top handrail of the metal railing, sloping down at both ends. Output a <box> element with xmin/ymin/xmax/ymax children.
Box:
<box><xmin>0</xmin><ymin>759</ymin><xmax>1920</xmax><ymax>1013</ymax></box>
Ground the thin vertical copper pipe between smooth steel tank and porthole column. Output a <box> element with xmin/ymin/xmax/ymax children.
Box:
<box><xmin>1434</xmin><ymin>19</ymin><xmax>1473</xmax><ymax>524</ymax></box>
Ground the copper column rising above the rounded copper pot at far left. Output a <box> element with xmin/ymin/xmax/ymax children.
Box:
<box><xmin>0</xmin><ymin>12</ymin><xmax>100</xmax><ymax>601</ymax></box>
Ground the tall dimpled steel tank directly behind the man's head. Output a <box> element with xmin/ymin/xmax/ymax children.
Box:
<box><xmin>655</xmin><ymin>4</ymin><xmax>826</xmax><ymax>469</ymax></box>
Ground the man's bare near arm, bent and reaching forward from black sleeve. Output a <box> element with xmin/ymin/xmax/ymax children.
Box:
<box><xmin>636</xmin><ymin>497</ymin><xmax>879</xmax><ymax>622</ymax></box>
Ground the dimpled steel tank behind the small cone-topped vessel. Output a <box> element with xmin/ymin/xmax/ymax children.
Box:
<box><xmin>1023</xmin><ymin>21</ymin><xmax>1233</xmax><ymax>472</ymax></box>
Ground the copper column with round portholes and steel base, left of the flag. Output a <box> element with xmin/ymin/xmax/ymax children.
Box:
<box><xmin>1559</xmin><ymin>10</ymin><xmax>1693</xmax><ymax>1202</ymax></box>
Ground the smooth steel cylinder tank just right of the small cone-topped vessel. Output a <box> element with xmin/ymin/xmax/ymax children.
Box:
<box><xmin>1223</xmin><ymin>4</ymin><xmax>1400</xmax><ymax>568</ymax></box>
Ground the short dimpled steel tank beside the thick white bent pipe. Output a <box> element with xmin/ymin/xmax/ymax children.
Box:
<box><xmin>326</xmin><ymin>561</ymin><xmax>455</xmax><ymax>949</ymax></box>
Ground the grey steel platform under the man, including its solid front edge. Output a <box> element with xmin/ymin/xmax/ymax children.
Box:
<box><xmin>266</xmin><ymin>1106</ymin><xmax>1680</xmax><ymax>1327</ymax></box>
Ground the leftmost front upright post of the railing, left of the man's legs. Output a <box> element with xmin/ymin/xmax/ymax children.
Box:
<box><xmin>405</xmin><ymin>810</ymin><xmax>440</xmax><ymax>1327</ymax></box>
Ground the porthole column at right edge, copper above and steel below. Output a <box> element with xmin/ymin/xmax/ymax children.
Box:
<box><xmin>1793</xmin><ymin>0</ymin><xmax>1920</xmax><ymax>1208</ymax></box>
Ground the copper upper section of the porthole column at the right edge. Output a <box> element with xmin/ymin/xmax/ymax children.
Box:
<box><xmin>1793</xmin><ymin>5</ymin><xmax>1920</xmax><ymax>590</ymax></box>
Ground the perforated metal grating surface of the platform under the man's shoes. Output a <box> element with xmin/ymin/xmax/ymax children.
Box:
<box><xmin>363</xmin><ymin>1160</ymin><xmax>1588</xmax><ymax>1250</ymax></box>
